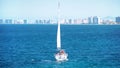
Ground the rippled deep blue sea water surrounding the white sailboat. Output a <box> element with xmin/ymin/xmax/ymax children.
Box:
<box><xmin>0</xmin><ymin>25</ymin><xmax>120</xmax><ymax>68</ymax></box>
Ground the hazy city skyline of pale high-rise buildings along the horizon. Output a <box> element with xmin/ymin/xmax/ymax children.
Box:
<box><xmin>0</xmin><ymin>16</ymin><xmax>120</xmax><ymax>25</ymax></box>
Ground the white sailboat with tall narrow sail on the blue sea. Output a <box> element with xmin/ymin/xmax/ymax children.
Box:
<box><xmin>55</xmin><ymin>2</ymin><xmax>68</xmax><ymax>62</ymax></box>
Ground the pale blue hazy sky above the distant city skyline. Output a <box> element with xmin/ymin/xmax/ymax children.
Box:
<box><xmin>0</xmin><ymin>0</ymin><xmax>120</xmax><ymax>18</ymax></box>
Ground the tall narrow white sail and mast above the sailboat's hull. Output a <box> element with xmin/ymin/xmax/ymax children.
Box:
<box><xmin>57</xmin><ymin>1</ymin><xmax>61</xmax><ymax>50</ymax></box>
